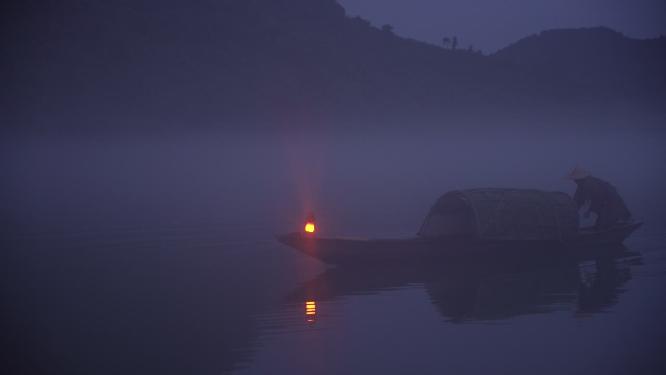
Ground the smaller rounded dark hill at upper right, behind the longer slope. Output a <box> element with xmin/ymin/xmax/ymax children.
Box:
<box><xmin>493</xmin><ymin>27</ymin><xmax>666</xmax><ymax>107</ymax></box>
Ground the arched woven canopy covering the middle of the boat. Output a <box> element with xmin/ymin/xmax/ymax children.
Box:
<box><xmin>418</xmin><ymin>189</ymin><xmax>578</xmax><ymax>241</ymax></box>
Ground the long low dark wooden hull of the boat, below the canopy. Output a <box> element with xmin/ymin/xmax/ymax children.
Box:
<box><xmin>277</xmin><ymin>223</ymin><xmax>641</xmax><ymax>265</ymax></box>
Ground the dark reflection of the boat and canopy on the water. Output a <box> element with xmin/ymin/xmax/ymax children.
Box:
<box><xmin>288</xmin><ymin>248</ymin><xmax>641</xmax><ymax>323</ymax></box>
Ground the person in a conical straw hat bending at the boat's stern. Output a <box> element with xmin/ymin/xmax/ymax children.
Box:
<box><xmin>567</xmin><ymin>167</ymin><xmax>631</xmax><ymax>230</ymax></box>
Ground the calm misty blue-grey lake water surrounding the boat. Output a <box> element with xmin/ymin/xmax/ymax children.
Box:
<box><xmin>5</xmin><ymin>129</ymin><xmax>666</xmax><ymax>374</ymax></box>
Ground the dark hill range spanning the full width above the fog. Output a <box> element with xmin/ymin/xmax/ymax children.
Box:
<box><xmin>3</xmin><ymin>0</ymin><xmax>666</xmax><ymax>127</ymax></box>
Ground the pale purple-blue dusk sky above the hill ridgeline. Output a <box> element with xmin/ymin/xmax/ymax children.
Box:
<box><xmin>339</xmin><ymin>0</ymin><xmax>666</xmax><ymax>52</ymax></box>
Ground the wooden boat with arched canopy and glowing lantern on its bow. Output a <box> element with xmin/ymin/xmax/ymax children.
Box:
<box><xmin>277</xmin><ymin>189</ymin><xmax>642</xmax><ymax>265</ymax></box>
